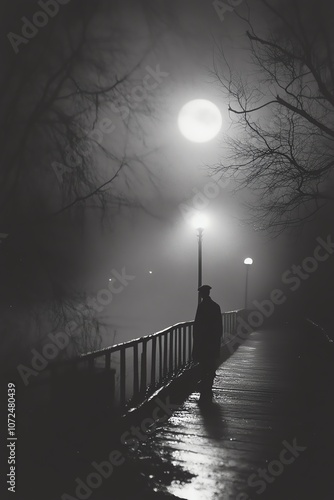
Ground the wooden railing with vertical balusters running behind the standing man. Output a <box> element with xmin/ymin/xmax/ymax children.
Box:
<box><xmin>52</xmin><ymin>311</ymin><xmax>238</xmax><ymax>409</ymax></box>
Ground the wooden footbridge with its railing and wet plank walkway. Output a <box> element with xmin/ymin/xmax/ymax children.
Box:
<box><xmin>12</xmin><ymin>310</ymin><xmax>334</xmax><ymax>500</ymax></box>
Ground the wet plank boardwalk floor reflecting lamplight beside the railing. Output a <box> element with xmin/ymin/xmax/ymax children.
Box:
<box><xmin>143</xmin><ymin>326</ymin><xmax>334</xmax><ymax>500</ymax></box>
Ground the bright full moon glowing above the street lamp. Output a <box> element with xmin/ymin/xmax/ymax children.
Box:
<box><xmin>178</xmin><ymin>99</ymin><xmax>223</xmax><ymax>142</ymax></box>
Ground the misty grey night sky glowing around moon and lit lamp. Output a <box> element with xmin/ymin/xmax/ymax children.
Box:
<box><xmin>0</xmin><ymin>0</ymin><xmax>334</xmax><ymax>365</ymax></box>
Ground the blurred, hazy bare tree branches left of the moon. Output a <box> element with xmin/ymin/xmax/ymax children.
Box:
<box><xmin>0</xmin><ymin>0</ymin><xmax>170</xmax><ymax>368</ymax></box>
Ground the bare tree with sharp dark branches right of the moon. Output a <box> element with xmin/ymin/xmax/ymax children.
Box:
<box><xmin>214</xmin><ymin>0</ymin><xmax>334</xmax><ymax>233</ymax></box>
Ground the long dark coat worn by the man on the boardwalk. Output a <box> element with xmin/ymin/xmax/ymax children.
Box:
<box><xmin>193</xmin><ymin>297</ymin><xmax>223</xmax><ymax>362</ymax></box>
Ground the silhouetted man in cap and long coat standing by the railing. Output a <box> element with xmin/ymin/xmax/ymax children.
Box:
<box><xmin>193</xmin><ymin>285</ymin><xmax>223</xmax><ymax>399</ymax></box>
